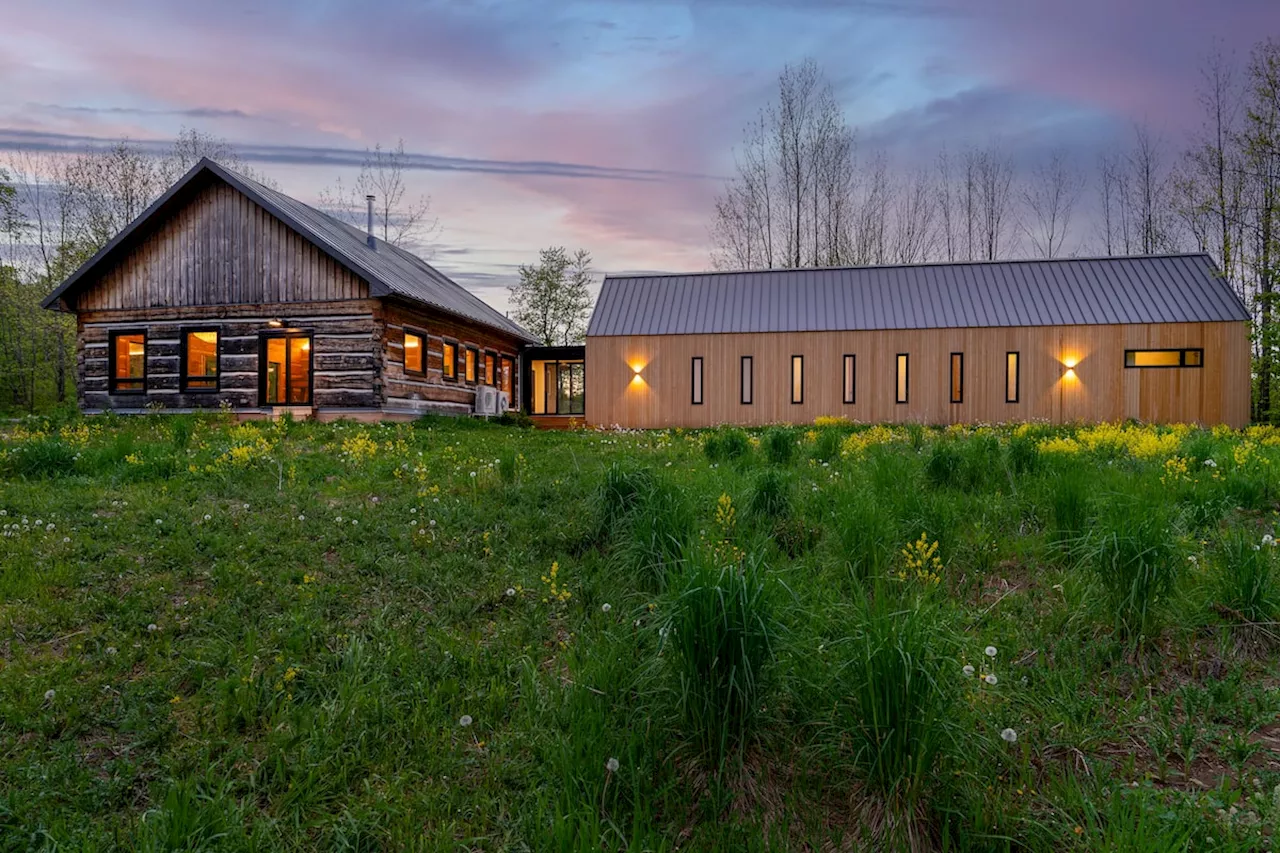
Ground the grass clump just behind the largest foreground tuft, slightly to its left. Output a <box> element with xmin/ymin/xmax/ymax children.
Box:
<box><xmin>621</xmin><ymin>473</ymin><xmax>695</xmax><ymax>589</ymax></box>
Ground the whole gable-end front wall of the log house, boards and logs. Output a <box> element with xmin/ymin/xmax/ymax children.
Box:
<box><xmin>73</xmin><ymin>181</ymin><xmax>381</xmax><ymax>410</ymax></box>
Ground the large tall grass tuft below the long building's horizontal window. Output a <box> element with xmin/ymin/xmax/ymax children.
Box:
<box><xmin>1088</xmin><ymin>497</ymin><xmax>1180</xmax><ymax>643</ymax></box>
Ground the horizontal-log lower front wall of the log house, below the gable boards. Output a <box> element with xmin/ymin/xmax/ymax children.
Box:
<box><xmin>77</xmin><ymin>300</ymin><xmax>383</xmax><ymax>411</ymax></box>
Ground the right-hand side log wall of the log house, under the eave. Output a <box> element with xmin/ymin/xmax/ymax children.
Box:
<box><xmin>381</xmin><ymin>302</ymin><xmax>521</xmax><ymax>411</ymax></box>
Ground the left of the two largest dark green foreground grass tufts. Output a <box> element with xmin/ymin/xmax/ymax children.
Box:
<box><xmin>663</xmin><ymin>552</ymin><xmax>778</xmax><ymax>768</ymax></box>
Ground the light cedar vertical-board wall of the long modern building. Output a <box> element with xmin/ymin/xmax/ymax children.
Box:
<box><xmin>586</xmin><ymin>323</ymin><xmax>1251</xmax><ymax>428</ymax></box>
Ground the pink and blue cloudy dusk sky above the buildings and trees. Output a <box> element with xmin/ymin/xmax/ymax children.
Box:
<box><xmin>0</xmin><ymin>0</ymin><xmax>1280</xmax><ymax>309</ymax></box>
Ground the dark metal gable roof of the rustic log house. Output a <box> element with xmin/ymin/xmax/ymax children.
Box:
<box><xmin>42</xmin><ymin>158</ymin><xmax>536</xmax><ymax>342</ymax></box>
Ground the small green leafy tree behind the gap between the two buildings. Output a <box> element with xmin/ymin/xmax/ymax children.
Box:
<box><xmin>509</xmin><ymin>246</ymin><xmax>591</xmax><ymax>346</ymax></box>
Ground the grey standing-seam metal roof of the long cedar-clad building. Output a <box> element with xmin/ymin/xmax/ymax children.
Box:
<box><xmin>586</xmin><ymin>254</ymin><xmax>1249</xmax><ymax>337</ymax></box>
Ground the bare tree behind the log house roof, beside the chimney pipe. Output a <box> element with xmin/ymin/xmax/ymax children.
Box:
<box><xmin>320</xmin><ymin>140</ymin><xmax>440</xmax><ymax>254</ymax></box>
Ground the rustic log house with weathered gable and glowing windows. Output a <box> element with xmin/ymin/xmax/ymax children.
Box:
<box><xmin>45</xmin><ymin>160</ymin><xmax>532</xmax><ymax>420</ymax></box>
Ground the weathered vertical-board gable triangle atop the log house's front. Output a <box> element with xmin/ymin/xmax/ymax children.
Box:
<box><xmin>72</xmin><ymin>182</ymin><xmax>369</xmax><ymax>311</ymax></box>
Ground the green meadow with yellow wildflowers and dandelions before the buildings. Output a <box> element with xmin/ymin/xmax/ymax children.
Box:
<box><xmin>0</xmin><ymin>415</ymin><xmax>1280</xmax><ymax>853</ymax></box>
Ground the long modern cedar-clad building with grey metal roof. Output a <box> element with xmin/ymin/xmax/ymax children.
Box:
<box><xmin>585</xmin><ymin>254</ymin><xmax>1251</xmax><ymax>428</ymax></box>
